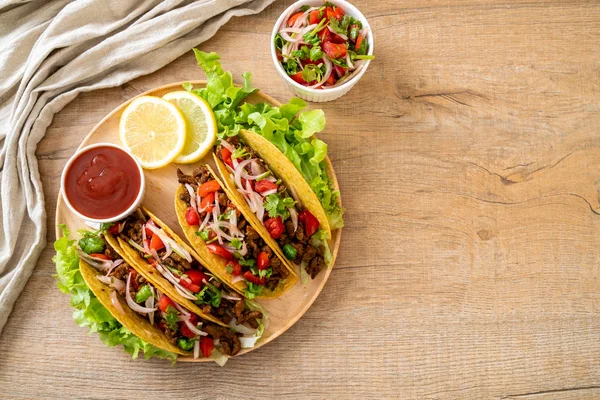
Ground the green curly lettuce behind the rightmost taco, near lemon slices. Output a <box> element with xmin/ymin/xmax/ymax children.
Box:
<box><xmin>183</xmin><ymin>49</ymin><xmax>344</xmax><ymax>229</ymax></box>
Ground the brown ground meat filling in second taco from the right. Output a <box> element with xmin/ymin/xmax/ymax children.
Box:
<box><xmin>177</xmin><ymin>166</ymin><xmax>289</xmax><ymax>290</ymax></box>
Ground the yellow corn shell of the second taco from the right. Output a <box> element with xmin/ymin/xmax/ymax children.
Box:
<box><xmin>175</xmin><ymin>165</ymin><xmax>298</xmax><ymax>299</ymax></box>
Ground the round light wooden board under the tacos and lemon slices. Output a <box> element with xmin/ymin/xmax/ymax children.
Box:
<box><xmin>56</xmin><ymin>81</ymin><xmax>342</xmax><ymax>362</ymax></box>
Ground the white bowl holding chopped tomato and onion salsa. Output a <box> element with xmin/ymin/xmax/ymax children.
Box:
<box><xmin>271</xmin><ymin>0</ymin><xmax>374</xmax><ymax>103</ymax></box>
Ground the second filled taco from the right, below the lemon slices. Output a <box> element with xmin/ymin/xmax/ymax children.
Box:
<box><xmin>175</xmin><ymin>165</ymin><xmax>298</xmax><ymax>298</ymax></box>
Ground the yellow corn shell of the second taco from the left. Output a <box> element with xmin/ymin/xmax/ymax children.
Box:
<box><xmin>105</xmin><ymin>219</ymin><xmax>229</xmax><ymax>327</ymax></box>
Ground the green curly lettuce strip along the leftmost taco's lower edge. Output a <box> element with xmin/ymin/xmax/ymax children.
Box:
<box><xmin>52</xmin><ymin>225</ymin><xmax>177</xmax><ymax>361</ymax></box>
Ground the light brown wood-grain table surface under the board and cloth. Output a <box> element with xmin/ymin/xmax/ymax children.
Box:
<box><xmin>0</xmin><ymin>0</ymin><xmax>600</xmax><ymax>399</ymax></box>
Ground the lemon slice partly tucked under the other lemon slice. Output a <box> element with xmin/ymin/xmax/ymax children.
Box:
<box><xmin>163</xmin><ymin>91</ymin><xmax>217</xmax><ymax>164</ymax></box>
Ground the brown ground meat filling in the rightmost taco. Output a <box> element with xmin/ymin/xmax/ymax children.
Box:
<box><xmin>216</xmin><ymin>136</ymin><xmax>325</xmax><ymax>278</ymax></box>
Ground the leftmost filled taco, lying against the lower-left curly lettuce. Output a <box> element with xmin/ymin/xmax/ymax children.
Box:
<box><xmin>77</xmin><ymin>232</ymin><xmax>262</xmax><ymax>364</ymax></box>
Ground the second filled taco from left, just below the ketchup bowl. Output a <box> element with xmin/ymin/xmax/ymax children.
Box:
<box><xmin>106</xmin><ymin>209</ymin><xmax>264</xmax><ymax>348</ymax></box>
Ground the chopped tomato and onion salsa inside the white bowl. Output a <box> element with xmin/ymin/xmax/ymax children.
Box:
<box><xmin>274</xmin><ymin>2</ymin><xmax>374</xmax><ymax>89</ymax></box>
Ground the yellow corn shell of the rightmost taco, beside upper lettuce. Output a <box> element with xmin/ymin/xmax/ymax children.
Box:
<box><xmin>238</xmin><ymin>130</ymin><xmax>331</xmax><ymax>240</ymax></box>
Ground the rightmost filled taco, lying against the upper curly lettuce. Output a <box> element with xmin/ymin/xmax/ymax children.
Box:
<box><xmin>213</xmin><ymin>130</ymin><xmax>331</xmax><ymax>281</ymax></box>
